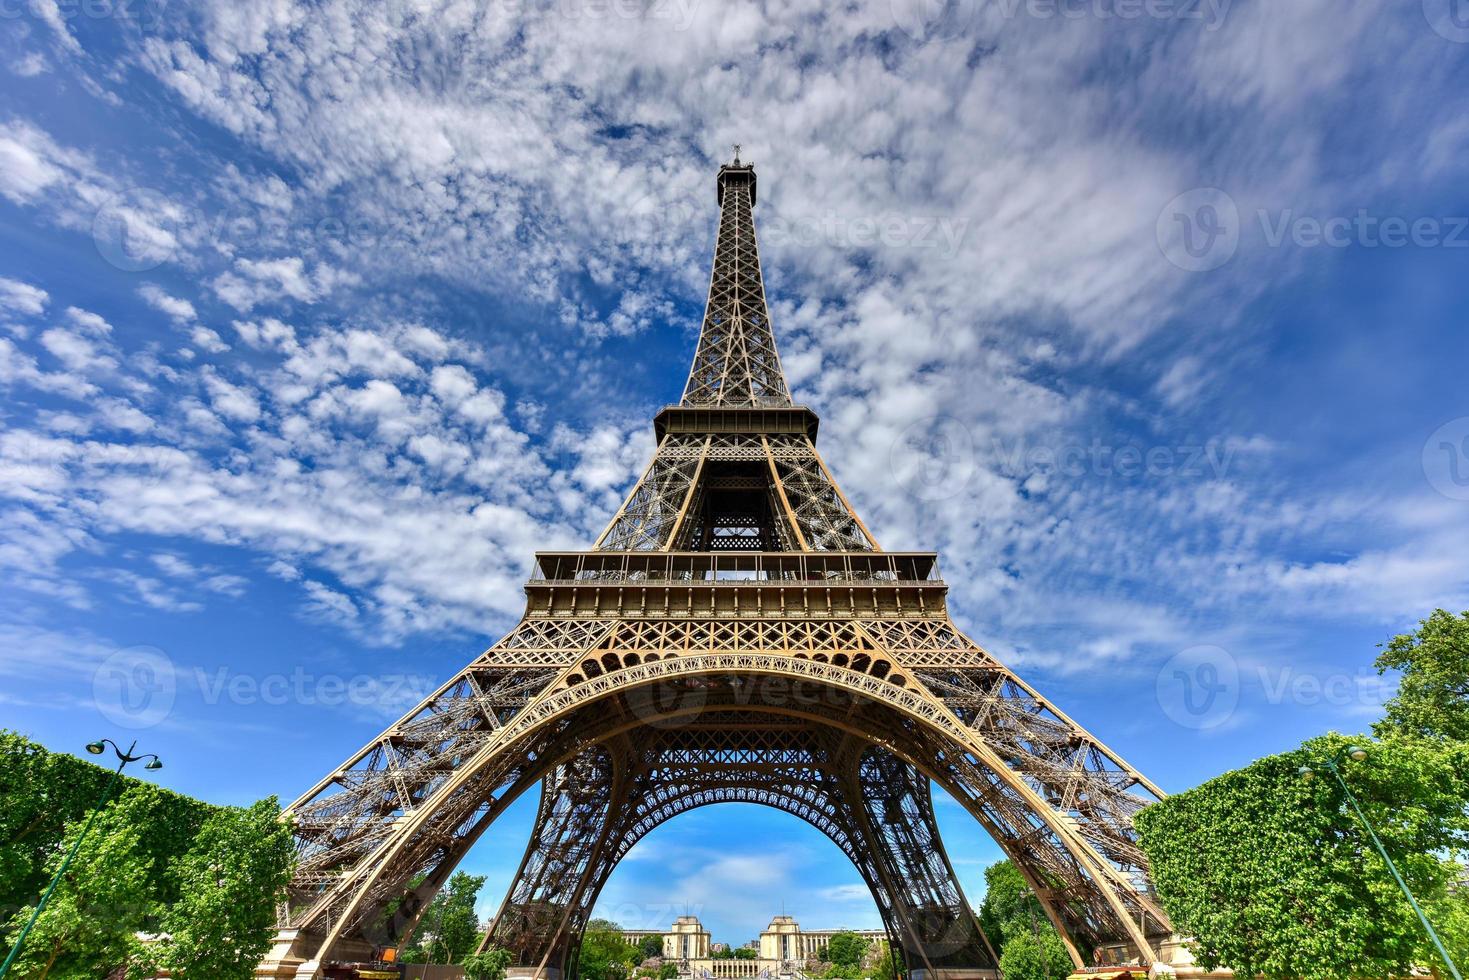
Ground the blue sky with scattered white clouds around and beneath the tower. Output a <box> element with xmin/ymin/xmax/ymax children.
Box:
<box><xmin>0</xmin><ymin>0</ymin><xmax>1469</xmax><ymax>940</ymax></box>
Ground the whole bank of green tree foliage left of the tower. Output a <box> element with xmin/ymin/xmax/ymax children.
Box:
<box><xmin>0</xmin><ymin>732</ymin><xmax>294</xmax><ymax>980</ymax></box>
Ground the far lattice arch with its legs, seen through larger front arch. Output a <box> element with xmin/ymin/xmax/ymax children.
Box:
<box><xmin>485</xmin><ymin>719</ymin><xmax>995</xmax><ymax>976</ymax></box>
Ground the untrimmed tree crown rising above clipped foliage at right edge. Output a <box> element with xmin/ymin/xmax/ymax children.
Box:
<box><xmin>1374</xmin><ymin>610</ymin><xmax>1469</xmax><ymax>742</ymax></box>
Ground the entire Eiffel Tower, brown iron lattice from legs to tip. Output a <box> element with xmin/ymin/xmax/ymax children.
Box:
<box><xmin>259</xmin><ymin>148</ymin><xmax>1171</xmax><ymax>980</ymax></box>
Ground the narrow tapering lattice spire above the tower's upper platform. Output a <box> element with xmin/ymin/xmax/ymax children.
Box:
<box><xmin>683</xmin><ymin>155</ymin><xmax>790</xmax><ymax>407</ymax></box>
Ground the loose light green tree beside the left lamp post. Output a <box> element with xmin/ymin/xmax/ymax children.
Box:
<box><xmin>7</xmin><ymin>783</ymin><xmax>166</xmax><ymax>980</ymax></box>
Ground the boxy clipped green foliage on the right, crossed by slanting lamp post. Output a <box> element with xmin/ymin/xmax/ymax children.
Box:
<box><xmin>1137</xmin><ymin>735</ymin><xmax>1469</xmax><ymax>980</ymax></box>
